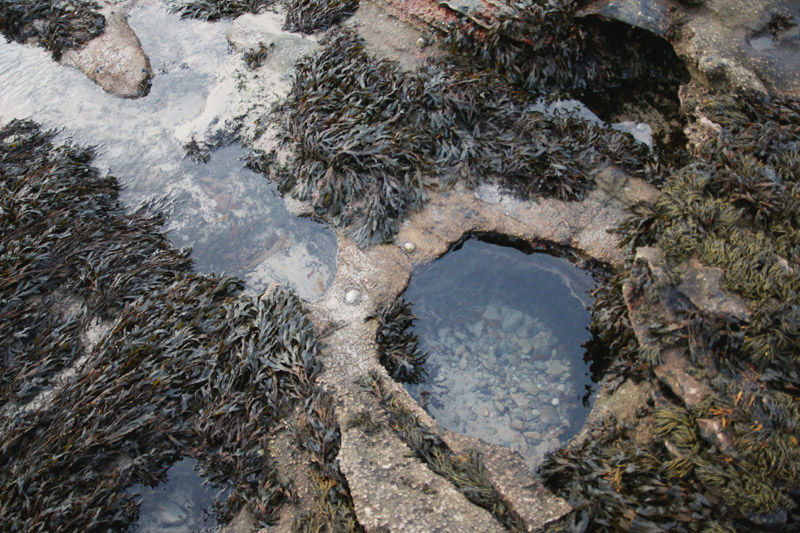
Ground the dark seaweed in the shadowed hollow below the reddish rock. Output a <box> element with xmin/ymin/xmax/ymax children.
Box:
<box><xmin>446</xmin><ymin>0</ymin><xmax>689</xmax><ymax>158</ymax></box>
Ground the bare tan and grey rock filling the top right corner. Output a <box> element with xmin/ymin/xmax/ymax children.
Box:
<box><xmin>581</xmin><ymin>0</ymin><xmax>800</xmax><ymax>96</ymax></box>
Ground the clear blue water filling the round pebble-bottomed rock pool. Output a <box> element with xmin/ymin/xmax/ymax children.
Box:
<box><xmin>404</xmin><ymin>238</ymin><xmax>594</xmax><ymax>465</ymax></box>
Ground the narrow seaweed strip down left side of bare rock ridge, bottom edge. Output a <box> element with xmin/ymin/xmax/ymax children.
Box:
<box><xmin>292</xmin><ymin>390</ymin><xmax>364</xmax><ymax>533</ymax></box>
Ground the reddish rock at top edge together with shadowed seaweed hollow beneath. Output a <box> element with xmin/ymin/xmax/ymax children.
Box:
<box><xmin>378</xmin><ymin>0</ymin><xmax>689</xmax><ymax>152</ymax></box>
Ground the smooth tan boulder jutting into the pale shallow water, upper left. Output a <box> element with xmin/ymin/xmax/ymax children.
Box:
<box><xmin>61</xmin><ymin>9</ymin><xmax>153</xmax><ymax>98</ymax></box>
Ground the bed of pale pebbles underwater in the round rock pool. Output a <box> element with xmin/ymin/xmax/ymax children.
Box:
<box><xmin>404</xmin><ymin>304</ymin><xmax>588</xmax><ymax>461</ymax></box>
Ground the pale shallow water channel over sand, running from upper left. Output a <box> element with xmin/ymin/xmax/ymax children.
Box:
<box><xmin>0</xmin><ymin>6</ymin><xmax>337</xmax><ymax>299</ymax></box>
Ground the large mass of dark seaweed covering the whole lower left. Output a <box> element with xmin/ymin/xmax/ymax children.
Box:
<box><xmin>0</xmin><ymin>121</ymin><xmax>319</xmax><ymax>531</ymax></box>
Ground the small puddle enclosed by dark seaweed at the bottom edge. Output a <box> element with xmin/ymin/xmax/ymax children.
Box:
<box><xmin>126</xmin><ymin>457</ymin><xmax>219</xmax><ymax>533</ymax></box>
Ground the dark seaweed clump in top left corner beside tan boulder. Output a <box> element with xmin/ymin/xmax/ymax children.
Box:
<box><xmin>0</xmin><ymin>0</ymin><xmax>106</xmax><ymax>61</ymax></box>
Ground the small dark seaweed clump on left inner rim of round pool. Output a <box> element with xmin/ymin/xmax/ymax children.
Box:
<box><xmin>367</xmin><ymin>298</ymin><xmax>428</xmax><ymax>383</ymax></box>
